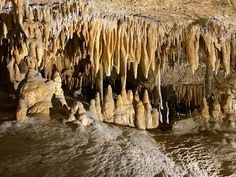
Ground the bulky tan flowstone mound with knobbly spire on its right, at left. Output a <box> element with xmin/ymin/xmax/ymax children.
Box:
<box><xmin>16</xmin><ymin>69</ymin><xmax>67</xmax><ymax>121</ymax></box>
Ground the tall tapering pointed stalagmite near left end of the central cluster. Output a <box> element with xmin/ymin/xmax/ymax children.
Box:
<box><xmin>102</xmin><ymin>85</ymin><xmax>115</xmax><ymax>123</ymax></box>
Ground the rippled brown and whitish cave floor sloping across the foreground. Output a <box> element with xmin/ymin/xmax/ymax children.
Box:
<box><xmin>0</xmin><ymin>115</ymin><xmax>236</xmax><ymax>177</ymax></box>
